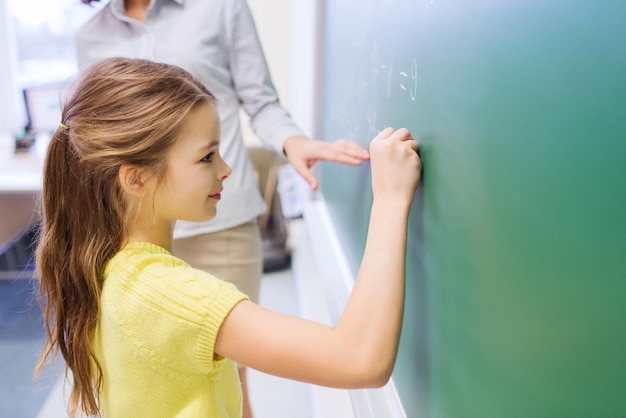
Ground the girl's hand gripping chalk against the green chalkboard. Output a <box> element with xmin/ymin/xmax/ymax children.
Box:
<box><xmin>370</xmin><ymin>128</ymin><xmax>422</xmax><ymax>205</ymax></box>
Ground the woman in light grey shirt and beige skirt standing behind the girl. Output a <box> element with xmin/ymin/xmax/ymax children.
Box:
<box><xmin>76</xmin><ymin>0</ymin><xmax>369</xmax><ymax>412</ymax></box>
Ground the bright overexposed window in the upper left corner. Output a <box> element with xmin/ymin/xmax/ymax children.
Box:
<box><xmin>0</xmin><ymin>0</ymin><xmax>106</xmax><ymax>136</ymax></box>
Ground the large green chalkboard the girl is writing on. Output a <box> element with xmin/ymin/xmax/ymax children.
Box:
<box><xmin>322</xmin><ymin>0</ymin><xmax>626</xmax><ymax>418</ymax></box>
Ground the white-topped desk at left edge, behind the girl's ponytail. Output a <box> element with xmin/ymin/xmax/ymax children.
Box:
<box><xmin>0</xmin><ymin>135</ymin><xmax>49</xmax><ymax>253</ymax></box>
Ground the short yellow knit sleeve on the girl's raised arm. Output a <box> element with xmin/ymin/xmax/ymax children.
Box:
<box><xmin>106</xmin><ymin>264</ymin><xmax>247</xmax><ymax>374</ymax></box>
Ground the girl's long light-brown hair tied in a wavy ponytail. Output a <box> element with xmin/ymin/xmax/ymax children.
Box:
<box><xmin>36</xmin><ymin>58</ymin><xmax>215</xmax><ymax>416</ymax></box>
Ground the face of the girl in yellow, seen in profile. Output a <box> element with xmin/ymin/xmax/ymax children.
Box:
<box><xmin>154</xmin><ymin>103</ymin><xmax>232</xmax><ymax>222</ymax></box>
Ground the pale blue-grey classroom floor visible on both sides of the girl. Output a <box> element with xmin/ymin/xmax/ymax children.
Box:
<box><xmin>0</xmin><ymin>220</ymin><xmax>313</xmax><ymax>418</ymax></box>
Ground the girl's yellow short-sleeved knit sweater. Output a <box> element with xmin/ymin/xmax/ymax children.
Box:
<box><xmin>94</xmin><ymin>243</ymin><xmax>247</xmax><ymax>418</ymax></box>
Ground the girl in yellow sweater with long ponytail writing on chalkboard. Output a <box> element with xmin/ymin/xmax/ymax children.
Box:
<box><xmin>37</xmin><ymin>58</ymin><xmax>421</xmax><ymax>417</ymax></box>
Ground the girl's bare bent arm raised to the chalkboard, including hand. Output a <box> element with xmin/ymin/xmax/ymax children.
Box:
<box><xmin>215</xmin><ymin>128</ymin><xmax>421</xmax><ymax>388</ymax></box>
